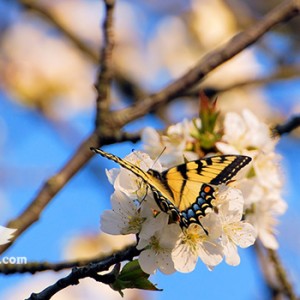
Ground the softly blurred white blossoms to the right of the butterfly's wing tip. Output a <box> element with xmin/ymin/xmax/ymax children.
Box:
<box><xmin>216</xmin><ymin>110</ymin><xmax>287</xmax><ymax>249</ymax></box>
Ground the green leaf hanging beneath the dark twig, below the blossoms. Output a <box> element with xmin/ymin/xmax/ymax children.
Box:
<box><xmin>110</xmin><ymin>260</ymin><xmax>161</xmax><ymax>296</ymax></box>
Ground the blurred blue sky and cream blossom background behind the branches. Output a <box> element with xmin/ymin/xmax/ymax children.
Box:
<box><xmin>0</xmin><ymin>0</ymin><xmax>300</xmax><ymax>300</ymax></box>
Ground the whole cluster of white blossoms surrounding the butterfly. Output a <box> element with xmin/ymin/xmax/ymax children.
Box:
<box><xmin>101</xmin><ymin>111</ymin><xmax>286</xmax><ymax>274</ymax></box>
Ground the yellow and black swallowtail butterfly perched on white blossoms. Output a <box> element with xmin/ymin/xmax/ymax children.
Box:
<box><xmin>91</xmin><ymin>148</ymin><xmax>251</xmax><ymax>227</ymax></box>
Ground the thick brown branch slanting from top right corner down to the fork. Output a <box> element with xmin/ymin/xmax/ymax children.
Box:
<box><xmin>115</xmin><ymin>0</ymin><xmax>300</xmax><ymax>127</ymax></box>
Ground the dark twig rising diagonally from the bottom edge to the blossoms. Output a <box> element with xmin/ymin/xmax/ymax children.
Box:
<box><xmin>24</xmin><ymin>246</ymin><xmax>140</xmax><ymax>300</ymax></box>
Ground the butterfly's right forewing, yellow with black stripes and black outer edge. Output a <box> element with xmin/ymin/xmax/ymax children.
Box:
<box><xmin>162</xmin><ymin>155</ymin><xmax>251</xmax><ymax>211</ymax></box>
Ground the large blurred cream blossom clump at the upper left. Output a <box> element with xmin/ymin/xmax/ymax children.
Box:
<box><xmin>1</xmin><ymin>18</ymin><xmax>94</xmax><ymax>115</ymax></box>
